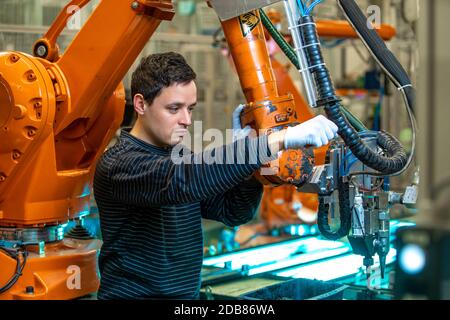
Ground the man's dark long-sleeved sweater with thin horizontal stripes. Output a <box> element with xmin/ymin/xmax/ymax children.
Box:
<box><xmin>94</xmin><ymin>130</ymin><xmax>276</xmax><ymax>299</ymax></box>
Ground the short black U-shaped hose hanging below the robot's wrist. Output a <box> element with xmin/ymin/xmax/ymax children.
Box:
<box><xmin>317</xmin><ymin>179</ymin><xmax>352</xmax><ymax>240</ymax></box>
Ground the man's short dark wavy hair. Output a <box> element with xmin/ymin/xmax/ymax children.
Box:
<box><xmin>131</xmin><ymin>52</ymin><xmax>197</xmax><ymax>104</ymax></box>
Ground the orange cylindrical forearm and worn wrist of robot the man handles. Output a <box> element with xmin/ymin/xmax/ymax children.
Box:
<box><xmin>222</xmin><ymin>11</ymin><xmax>314</xmax><ymax>185</ymax></box>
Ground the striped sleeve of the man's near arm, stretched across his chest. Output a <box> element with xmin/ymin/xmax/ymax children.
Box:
<box><xmin>108</xmin><ymin>135</ymin><xmax>277</xmax><ymax>206</ymax></box>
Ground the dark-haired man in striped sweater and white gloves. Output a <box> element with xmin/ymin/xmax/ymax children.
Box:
<box><xmin>94</xmin><ymin>52</ymin><xmax>337</xmax><ymax>299</ymax></box>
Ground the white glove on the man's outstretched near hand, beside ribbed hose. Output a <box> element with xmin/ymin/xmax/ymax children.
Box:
<box><xmin>284</xmin><ymin>115</ymin><xmax>338</xmax><ymax>149</ymax></box>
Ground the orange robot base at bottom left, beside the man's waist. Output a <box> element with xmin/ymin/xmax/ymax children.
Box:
<box><xmin>0</xmin><ymin>238</ymin><xmax>102</xmax><ymax>300</ymax></box>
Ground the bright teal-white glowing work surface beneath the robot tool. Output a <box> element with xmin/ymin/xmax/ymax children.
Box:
<box><xmin>203</xmin><ymin>220</ymin><xmax>414</xmax><ymax>280</ymax></box>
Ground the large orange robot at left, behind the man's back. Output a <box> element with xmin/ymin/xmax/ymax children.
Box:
<box><xmin>0</xmin><ymin>0</ymin><xmax>174</xmax><ymax>299</ymax></box>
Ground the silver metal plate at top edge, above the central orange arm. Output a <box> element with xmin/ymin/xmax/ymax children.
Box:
<box><xmin>210</xmin><ymin>0</ymin><xmax>281</xmax><ymax>21</ymax></box>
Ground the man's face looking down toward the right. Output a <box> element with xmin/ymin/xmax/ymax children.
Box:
<box><xmin>141</xmin><ymin>81</ymin><xmax>197</xmax><ymax>147</ymax></box>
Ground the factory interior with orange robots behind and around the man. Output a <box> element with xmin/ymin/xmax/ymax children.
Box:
<box><xmin>0</xmin><ymin>0</ymin><xmax>450</xmax><ymax>301</ymax></box>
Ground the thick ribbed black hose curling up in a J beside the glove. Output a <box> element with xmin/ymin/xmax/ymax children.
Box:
<box><xmin>300</xmin><ymin>16</ymin><xmax>408</xmax><ymax>175</ymax></box>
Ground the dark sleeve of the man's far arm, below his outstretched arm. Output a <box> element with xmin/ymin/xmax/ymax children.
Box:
<box><xmin>201</xmin><ymin>176</ymin><xmax>263</xmax><ymax>227</ymax></box>
